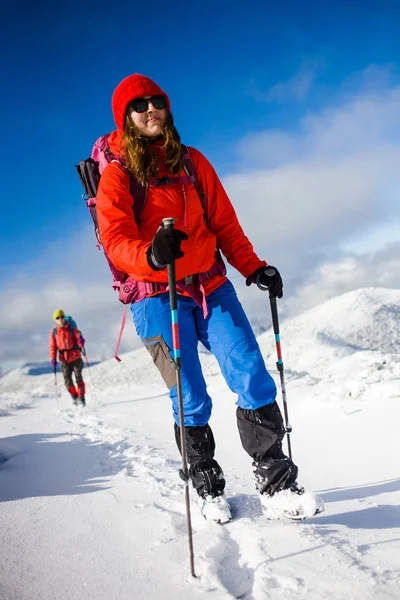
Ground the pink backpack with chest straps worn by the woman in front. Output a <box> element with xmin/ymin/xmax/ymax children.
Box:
<box><xmin>75</xmin><ymin>134</ymin><xmax>212</xmax><ymax>304</ymax></box>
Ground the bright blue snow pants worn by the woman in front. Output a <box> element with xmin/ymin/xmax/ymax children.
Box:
<box><xmin>131</xmin><ymin>281</ymin><xmax>276</xmax><ymax>427</ymax></box>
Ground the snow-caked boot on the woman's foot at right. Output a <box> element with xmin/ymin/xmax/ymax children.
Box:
<box><xmin>260</xmin><ymin>483</ymin><xmax>324</xmax><ymax>521</ymax></box>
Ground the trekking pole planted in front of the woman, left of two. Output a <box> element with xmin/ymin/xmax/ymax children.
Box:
<box><xmin>163</xmin><ymin>218</ymin><xmax>196</xmax><ymax>577</ymax></box>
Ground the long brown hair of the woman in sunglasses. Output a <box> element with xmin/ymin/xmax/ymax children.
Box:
<box><xmin>122</xmin><ymin>109</ymin><xmax>184</xmax><ymax>184</ymax></box>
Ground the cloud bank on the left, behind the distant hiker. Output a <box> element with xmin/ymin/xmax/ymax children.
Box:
<box><xmin>0</xmin><ymin>225</ymin><xmax>140</xmax><ymax>368</ymax></box>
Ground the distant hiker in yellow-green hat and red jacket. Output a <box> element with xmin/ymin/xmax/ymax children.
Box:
<box><xmin>49</xmin><ymin>309</ymin><xmax>86</xmax><ymax>406</ymax></box>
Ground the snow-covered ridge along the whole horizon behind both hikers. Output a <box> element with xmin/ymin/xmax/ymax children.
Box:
<box><xmin>0</xmin><ymin>288</ymin><xmax>400</xmax><ymax>399</ymax></box>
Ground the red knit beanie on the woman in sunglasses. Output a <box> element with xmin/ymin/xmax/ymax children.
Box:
<box><xmin>111</xmin><ymin>73</ymin><xmax>171</xmax><ymax>131</ymax></box>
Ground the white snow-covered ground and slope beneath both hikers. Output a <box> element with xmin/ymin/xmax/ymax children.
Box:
<box><xmin>0</xmin><ymin>289</ymin><xmax>400</xmax><ymax>600</ymax></box>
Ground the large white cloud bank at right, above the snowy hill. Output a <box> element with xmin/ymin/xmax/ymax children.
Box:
<box><xmin>224</xmin><ymin>68</ymin><xmax>400</xmax><ymax>311</ymax></box>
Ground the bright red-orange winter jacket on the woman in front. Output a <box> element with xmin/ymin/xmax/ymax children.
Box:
<box><xmin>97</xmin><ymin>131</ymin><xmax>266</xmax><ymax>295</ymax></box>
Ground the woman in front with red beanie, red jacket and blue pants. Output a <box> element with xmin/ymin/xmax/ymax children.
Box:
<box><xmin>97</xmin><ymin>74</ymin><xmax>322</xmax><ymax>522</ymax></box>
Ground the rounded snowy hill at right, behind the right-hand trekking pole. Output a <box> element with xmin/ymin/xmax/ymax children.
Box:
<box><xmin>259</xmin><ymin>288</ymin><xmax>400</xmax><ymax>377</ymax></box>
